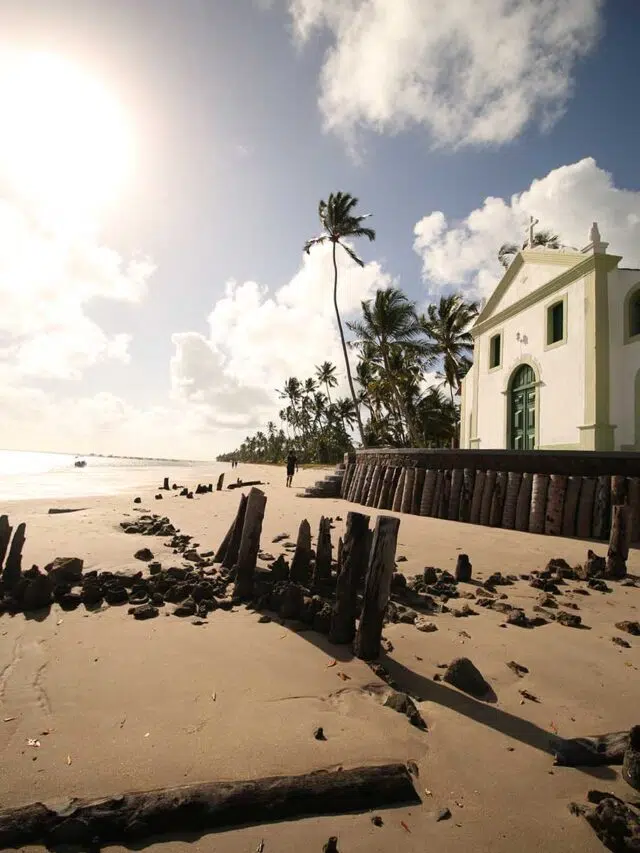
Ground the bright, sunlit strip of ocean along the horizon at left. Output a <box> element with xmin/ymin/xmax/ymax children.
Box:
<box><xmin>0</xmin><ymin>450</ymin><xmax>215</xmax><ymax>501</ymax></box>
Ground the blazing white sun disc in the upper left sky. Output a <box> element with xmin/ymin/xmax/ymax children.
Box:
<box><xmin>0</xmin><ymin>52</ymin><xmax>131</xmax><ymax>223</ymax></box>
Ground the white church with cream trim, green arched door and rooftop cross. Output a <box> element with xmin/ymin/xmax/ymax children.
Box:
<box><xmin>460</xmin><ymin>223</ymin><xmax>640</xmax><ymax>453</ymax></box>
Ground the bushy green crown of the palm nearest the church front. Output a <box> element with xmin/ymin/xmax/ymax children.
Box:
<box><xmin>420</xmin><ymin>294</ymin><xmax>479</xmax><ymax>403</ymax></box>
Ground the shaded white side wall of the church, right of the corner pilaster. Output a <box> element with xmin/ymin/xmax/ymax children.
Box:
<box><xmin>609</xmin><ymin>269</ymin><xmax>640</xmax><ymax>450</ymax></box>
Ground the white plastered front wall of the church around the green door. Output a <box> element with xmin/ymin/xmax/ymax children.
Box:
<box><xmin>474</xmin><ymin>282</ymin><xmax>585</xmax><ymax>448</ymax></box>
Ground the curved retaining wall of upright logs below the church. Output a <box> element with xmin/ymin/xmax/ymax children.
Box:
<box><xmin>342</xmin><ymin>448</ymin><xmax>640</xmax><ymax>543</ymax></box>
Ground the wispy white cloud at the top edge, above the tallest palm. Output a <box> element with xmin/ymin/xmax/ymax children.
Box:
<box><xmin>287</xmin><ymin>0</ymin><xmax>603</xmax><ymax>145</ymax></box>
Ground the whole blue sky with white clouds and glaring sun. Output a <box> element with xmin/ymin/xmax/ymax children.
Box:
<box><xmin>0</xmin><ymin>0</ymin><xmax>640</xmax><ymax>459</ymax></box>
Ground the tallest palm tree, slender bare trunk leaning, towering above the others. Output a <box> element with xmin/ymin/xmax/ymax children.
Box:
<box><xmin>304</xmin><ymin>192</ymin><xmax>376</xmax><ymax>447</ymax></box>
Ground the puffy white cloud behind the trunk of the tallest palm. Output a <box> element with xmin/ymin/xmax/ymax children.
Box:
<box><xmin>171</xmin><ymin>238</ymin><xmax>391</xmax><ymax>426</ymax></box>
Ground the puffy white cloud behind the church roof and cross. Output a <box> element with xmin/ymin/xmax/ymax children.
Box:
<box><xmin>414</xmin><ymin>157</ymin><xmax>640</xmax><ymax>297</ymax></box>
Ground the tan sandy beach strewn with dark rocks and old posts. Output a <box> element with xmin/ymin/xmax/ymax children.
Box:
<box><xmin>0</xmin><ymin>465</ymin><xmax>640</xmax><ymax>853</ymax></box>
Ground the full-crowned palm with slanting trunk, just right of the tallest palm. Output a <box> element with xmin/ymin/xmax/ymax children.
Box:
<box><xmin>347</xmin><ymin>287</ymin><xmax>422</xmax><ymax>441</ymax></box>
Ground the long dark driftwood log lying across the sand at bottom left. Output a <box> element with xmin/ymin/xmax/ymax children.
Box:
<box><xmin>0</xmin><ymin>764</ymin><xmax>420</xmax><ymax>850</ymax></box>
